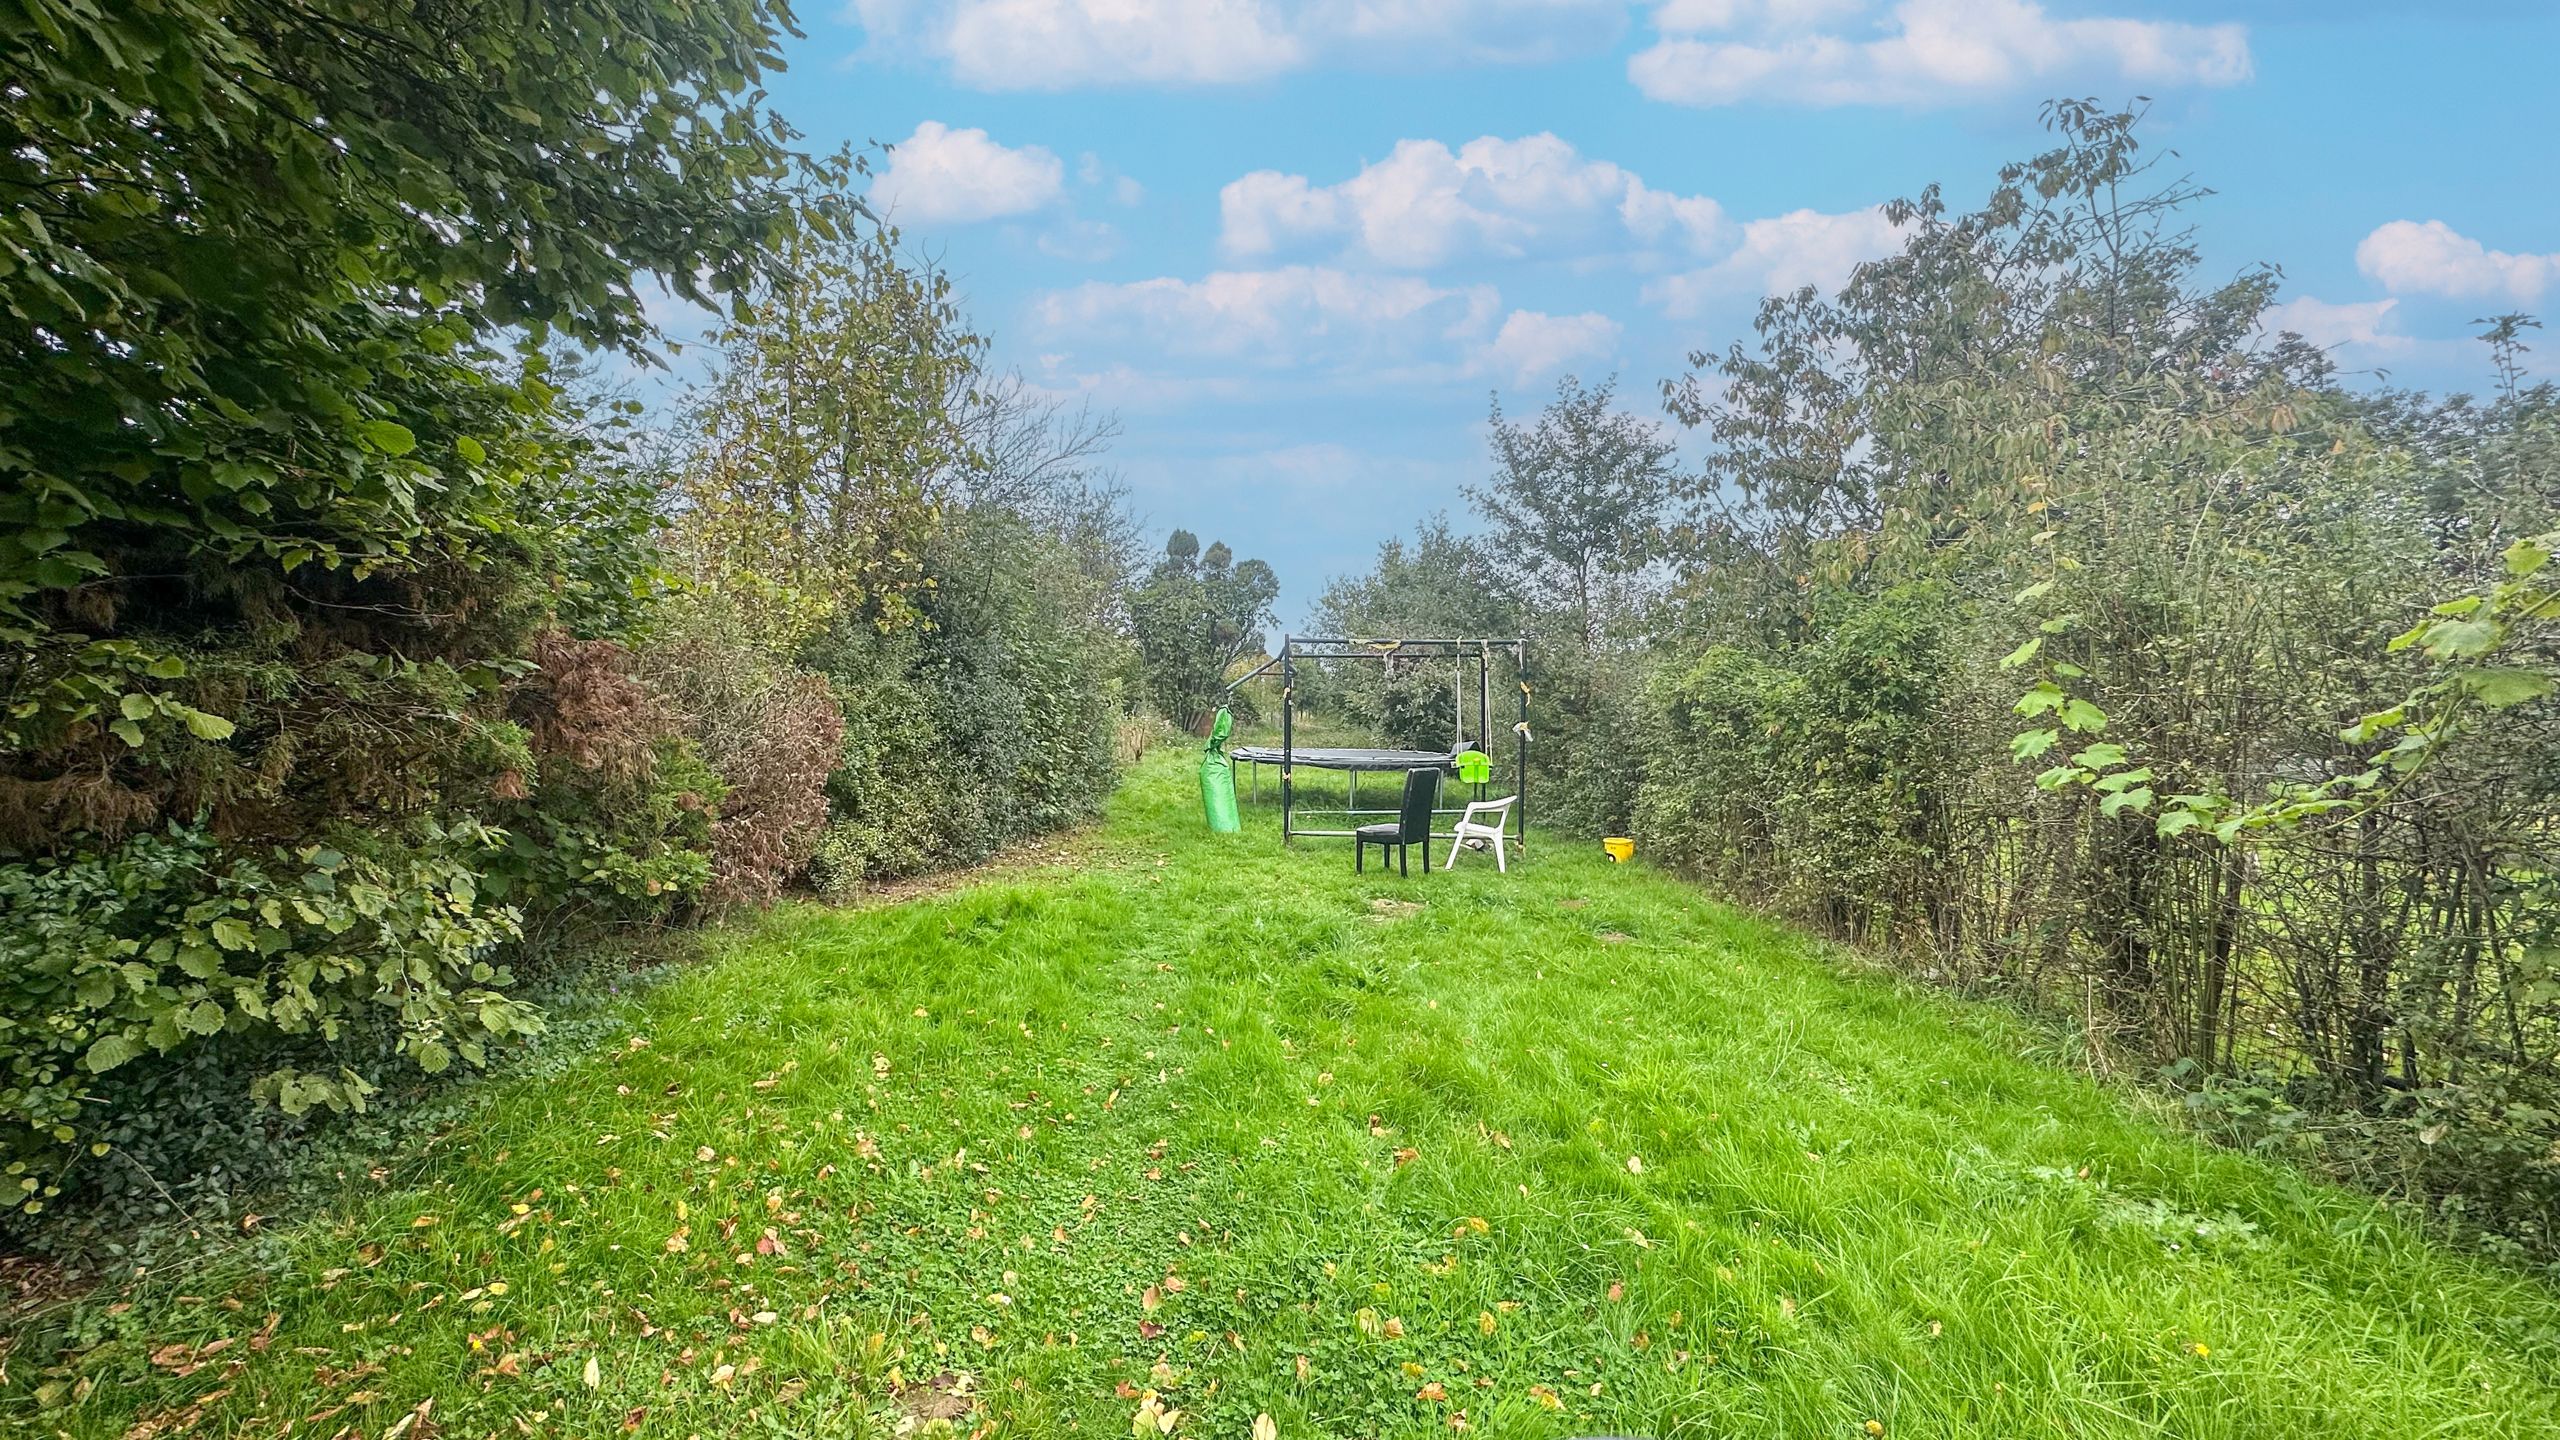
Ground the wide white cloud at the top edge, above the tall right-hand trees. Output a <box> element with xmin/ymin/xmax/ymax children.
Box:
<box><xmin>1626</xmin><ymin>0</ymin><xmax>2250</xmax><ymax>105</ymax></box>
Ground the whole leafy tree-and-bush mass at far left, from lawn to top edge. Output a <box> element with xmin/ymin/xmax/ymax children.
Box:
<box><xmin>0</xmin><ymin>0</ymin><xmax>858</xmax><ymax>1235</ymax></box>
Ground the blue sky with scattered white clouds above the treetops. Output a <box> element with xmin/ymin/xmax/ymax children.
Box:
<box><xmin>716</xmin><ymin>0</ymin><xmax>2560</xmax><ymax>620</ymax></box>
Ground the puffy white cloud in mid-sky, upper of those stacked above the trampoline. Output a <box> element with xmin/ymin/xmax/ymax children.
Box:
<box><xmin>1219</xmin><ymin>133</ymin><xmax>1725</xmax><ymax>269</ymax></box>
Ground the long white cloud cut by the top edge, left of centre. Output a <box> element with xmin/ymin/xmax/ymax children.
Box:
<box><xmin>850</xmin><ymin>0</ymin><xmax>1626</xmax><ymax>90</ymax></box>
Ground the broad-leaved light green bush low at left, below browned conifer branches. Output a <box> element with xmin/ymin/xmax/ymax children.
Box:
<box><xmin>0</xmin><ymin>822</ymin><xmax>540</xmax><ymax>1212</ymax></box>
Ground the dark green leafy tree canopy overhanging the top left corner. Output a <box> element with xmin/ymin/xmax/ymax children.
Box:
<box><xmin>0</xmin><ymin>0</ymin><xmax>842</xmax><ymax>748</ymax></box>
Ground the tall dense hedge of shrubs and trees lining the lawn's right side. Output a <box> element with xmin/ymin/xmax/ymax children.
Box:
<box><xmin>1638</xmin><ymin>102</ymin><xmax>2560</xmax><ymax>1253</ymax></box>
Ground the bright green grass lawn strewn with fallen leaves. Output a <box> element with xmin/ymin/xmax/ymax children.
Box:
<box><xmin>15</xmin><ymin>753</ymin><xmax>2560</xmax><ymax>1440</ymax></box>
